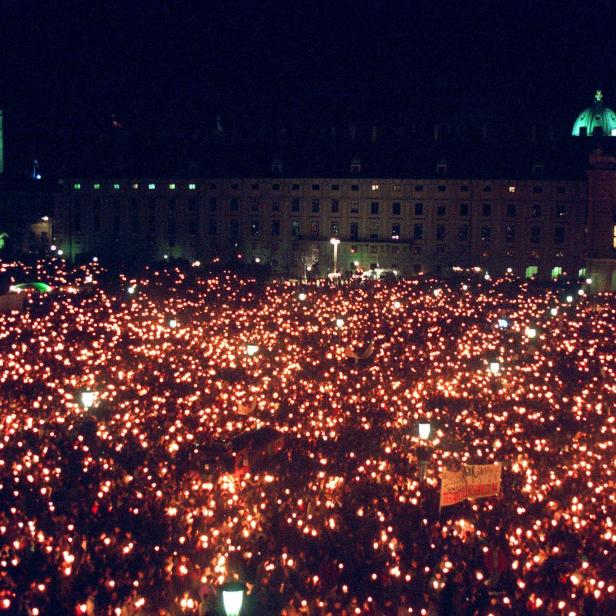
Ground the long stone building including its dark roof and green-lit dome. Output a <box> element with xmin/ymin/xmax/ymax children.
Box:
<box><xmin>54</xmin><ymin>94</ymin><xmax>616</xmax><ymax>290</ymax></box>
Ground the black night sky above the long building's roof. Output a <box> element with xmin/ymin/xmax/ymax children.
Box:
<box><xmin>0</xmin><ymin>0</ymin><xmax>616</xmax><ymax>132</ymax></box>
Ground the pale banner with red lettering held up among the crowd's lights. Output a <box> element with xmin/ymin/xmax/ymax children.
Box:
<box><xmin>439</xmin><ymin>462</ymin><xmax>502</xmax><ymax>507</ymax></box>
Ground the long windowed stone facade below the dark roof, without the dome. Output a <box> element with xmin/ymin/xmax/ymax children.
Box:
<box><xmin>54</xmin><ymin>172</ymin><xmax>587</xmax><ymax>278</ymax></box>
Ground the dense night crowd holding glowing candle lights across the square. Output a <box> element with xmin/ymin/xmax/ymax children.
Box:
<box><xmin>0</xmin><ymin>261</ymin><xmax>616</xmax><ymax>616</ymax></box>
